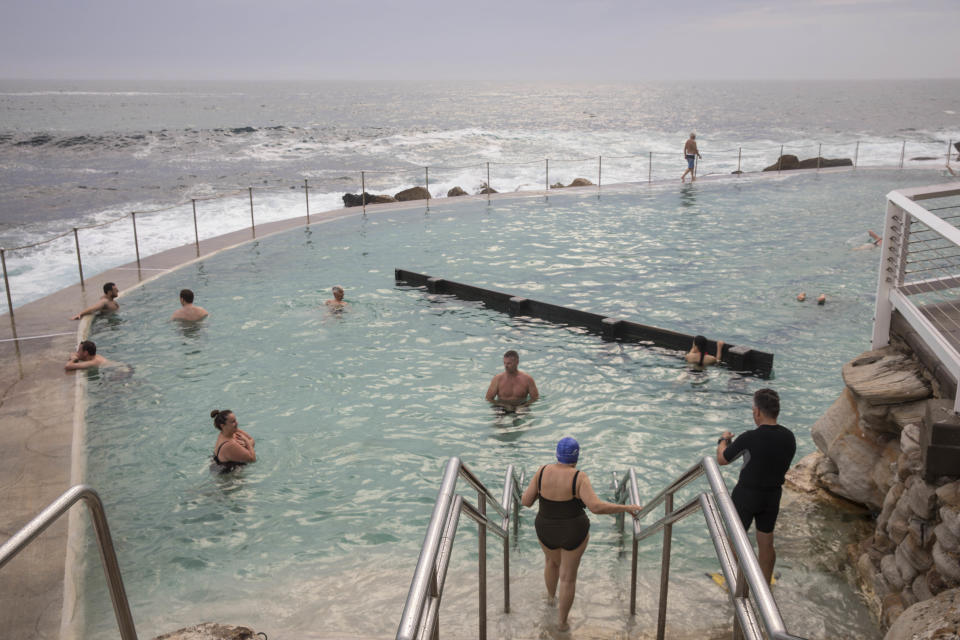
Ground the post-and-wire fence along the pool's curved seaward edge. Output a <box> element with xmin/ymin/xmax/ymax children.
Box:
<box><xmin>0</xmin><ymin>140</ymin><xmax>953</xmax><ymax>319</ymax></box>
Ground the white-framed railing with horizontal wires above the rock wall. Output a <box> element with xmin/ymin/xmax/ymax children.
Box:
<box><xmin>871</xmin><ymin>184</ymin><xmax>960</xmax><ymax>412</ymax></box>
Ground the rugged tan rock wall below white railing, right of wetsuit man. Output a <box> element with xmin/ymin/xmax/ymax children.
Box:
<box><xmin>803</xmin><ymin>347</ymin><xmax>960</xmax><ymax>640</ymax></box>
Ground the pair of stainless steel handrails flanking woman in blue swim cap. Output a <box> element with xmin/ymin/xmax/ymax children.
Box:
<box><xmin>396</xmin><ymin>456</ymin><xmax>803</xmax><ymax>640</ymax></box>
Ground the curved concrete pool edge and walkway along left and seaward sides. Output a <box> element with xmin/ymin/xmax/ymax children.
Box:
<box><xmin>0</xmin><ymin>167</ymin><xmax>942</xmax><ymax>638</ymax></box>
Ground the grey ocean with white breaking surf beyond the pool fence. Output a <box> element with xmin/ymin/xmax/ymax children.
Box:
<box><xmin>0</xmin><ymin>80</ymin><xmax>960</xmax><ymax>305</ymax></box>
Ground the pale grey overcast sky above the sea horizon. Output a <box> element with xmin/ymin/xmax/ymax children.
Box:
<box><xmin>0</xmin><ymin>0</ymin><xmax>960</xmax><ymax>82</ymax></box>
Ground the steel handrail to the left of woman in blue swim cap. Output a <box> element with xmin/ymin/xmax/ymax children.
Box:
<box><xmin>397</xmin><ymin>457</ymin><xmax>523</xmax><ymax>640</ymax></box>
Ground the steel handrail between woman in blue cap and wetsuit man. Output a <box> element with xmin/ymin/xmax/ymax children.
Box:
<box><xmin>613</xmin><ymin>456</ymin><xmax>802</xmax><ymax>640</ymax></box>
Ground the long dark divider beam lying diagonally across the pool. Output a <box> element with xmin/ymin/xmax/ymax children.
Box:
<box><xmin>394</xmin><ymin>269</ymin><xmax>773</xmax><ymax>378</ymax></box>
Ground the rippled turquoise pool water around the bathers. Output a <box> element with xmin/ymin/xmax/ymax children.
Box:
<box><xmin>84</xmin><ymin>171</ymin><xmax>938</xmax><ymax>638</ymax></box>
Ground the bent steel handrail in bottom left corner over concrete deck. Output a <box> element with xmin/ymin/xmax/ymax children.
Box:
<box><xmin>0</xmin><ymin>484</ymin><xmax>137</xmax><ymax>640</ymax></box>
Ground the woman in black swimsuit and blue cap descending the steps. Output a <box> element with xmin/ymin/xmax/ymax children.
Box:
<box><xmin>521</xmin><ymin>438</ymin><xmax>640</xmax><ymax>631</ymax></box>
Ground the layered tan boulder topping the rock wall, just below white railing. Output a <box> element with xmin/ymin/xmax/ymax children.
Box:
<box><xmin>843</xmin><ymin>347</ymin><xmax>930</xmax><ymax>404</ymax></box>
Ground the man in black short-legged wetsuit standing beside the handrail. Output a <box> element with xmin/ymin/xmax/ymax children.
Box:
<box><xmin>717</xmin><ymin>389</ymin><xmax>797</xmax><ymax>583</ymax></box>
